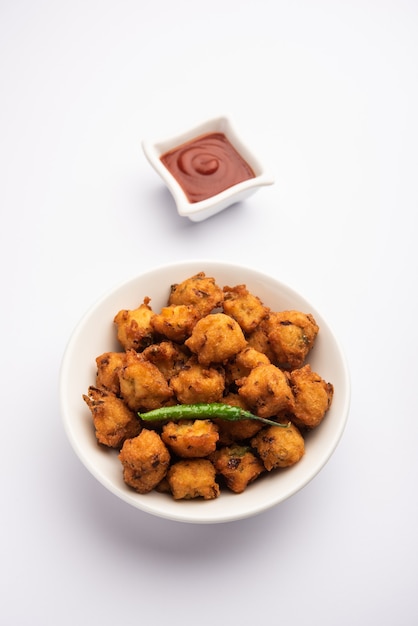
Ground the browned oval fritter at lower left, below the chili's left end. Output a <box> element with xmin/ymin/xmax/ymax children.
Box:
<box><xmin>119</xmin><ymin>428</ymin><xmax>170</xmax><ymax>493</ymax></box>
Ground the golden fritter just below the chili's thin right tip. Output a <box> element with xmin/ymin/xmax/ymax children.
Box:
<box><xmin>251</xmin><ymin>424</ymin><xmax>305</xmax><ymax>472</ymax></box>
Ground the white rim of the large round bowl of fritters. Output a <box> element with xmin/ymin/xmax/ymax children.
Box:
<box><xmin>59</xmin><ymin>259</ymin><xmax>351</xmax><ymax>524</ymax></box>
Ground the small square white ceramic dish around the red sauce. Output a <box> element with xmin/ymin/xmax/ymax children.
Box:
<box><xmin>142</xmin><ymin>117</ymin><xmax>274</xmax><ymax>222</ymax></box>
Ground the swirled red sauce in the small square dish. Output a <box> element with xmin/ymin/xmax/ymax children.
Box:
<box><xmin>160</xmin><ymin>133</ymin><xmax>255</xmax><ymax>202</ymax></box>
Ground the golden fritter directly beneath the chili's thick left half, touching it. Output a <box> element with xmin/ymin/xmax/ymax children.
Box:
<box><xmin>161</xmin><ymin>420</ymin><xmax>219</xmax><ymax>459</ymax></box>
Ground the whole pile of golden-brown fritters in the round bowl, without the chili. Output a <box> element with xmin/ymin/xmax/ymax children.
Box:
<box><xmin>83</xmin><ymin>272</ymin><xmax>333</xmax><ymax>500</ymax></box>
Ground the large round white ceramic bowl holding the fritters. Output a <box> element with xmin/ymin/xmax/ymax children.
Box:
<box><xmin>60</xmin><ymin>261</ymin><xmax>350</xmax><ymax>523</ymax></box>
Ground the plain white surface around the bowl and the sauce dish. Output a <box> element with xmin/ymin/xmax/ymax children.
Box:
<box><xmin>0</xmin><ymin>0</ymin><xmax>418</xmax><ymax>626</ymax></box>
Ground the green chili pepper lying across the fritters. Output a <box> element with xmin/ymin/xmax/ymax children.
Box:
<box><xmin>138</xmin><ymin>402</ymin><xmax>289</xmax><ymax>428</ymax></box>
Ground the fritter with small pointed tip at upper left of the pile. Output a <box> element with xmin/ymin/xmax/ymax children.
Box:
<box><xmin>113</xmin><ymin>297</ymin><xmax>155</xmax><ymax>351</ymax></box>
